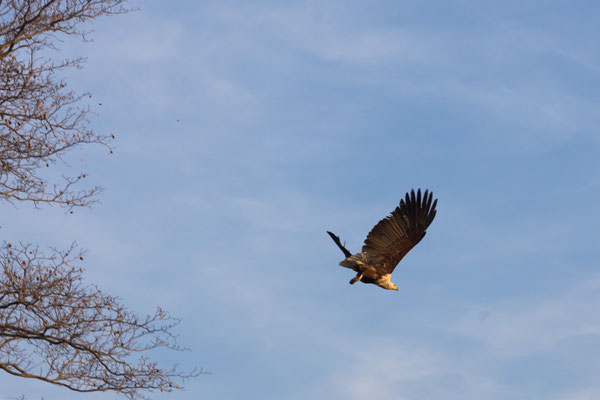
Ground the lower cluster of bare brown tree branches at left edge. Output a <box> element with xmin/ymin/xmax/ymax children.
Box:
<box><xmin>0</xmin><ymin>243</ymin><xmax>199</xmax><ymax>399</ymax></box>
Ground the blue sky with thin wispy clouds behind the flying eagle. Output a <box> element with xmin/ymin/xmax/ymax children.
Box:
<box><xmin>0</xmin><ymin>0</ymin><xmax>600</xmax><ymax>400</ymax></box>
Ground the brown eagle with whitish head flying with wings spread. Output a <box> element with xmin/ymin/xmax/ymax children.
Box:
<box><xmin>327</xmin><ymin>189</ymin><xmax>437</xmax><ymax>290</ymax></box>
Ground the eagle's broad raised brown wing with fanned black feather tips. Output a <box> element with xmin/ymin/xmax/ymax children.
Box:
<box><xmin>362</xmin><ymin>189</ymin><xmax>437</xmax><ymax>274</ymax></box>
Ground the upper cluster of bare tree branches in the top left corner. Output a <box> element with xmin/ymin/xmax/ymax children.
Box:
<box><xmin>0</xmin><ymin>0</ymin><xmax>127</xmax><ymax>207</ymax></box>
